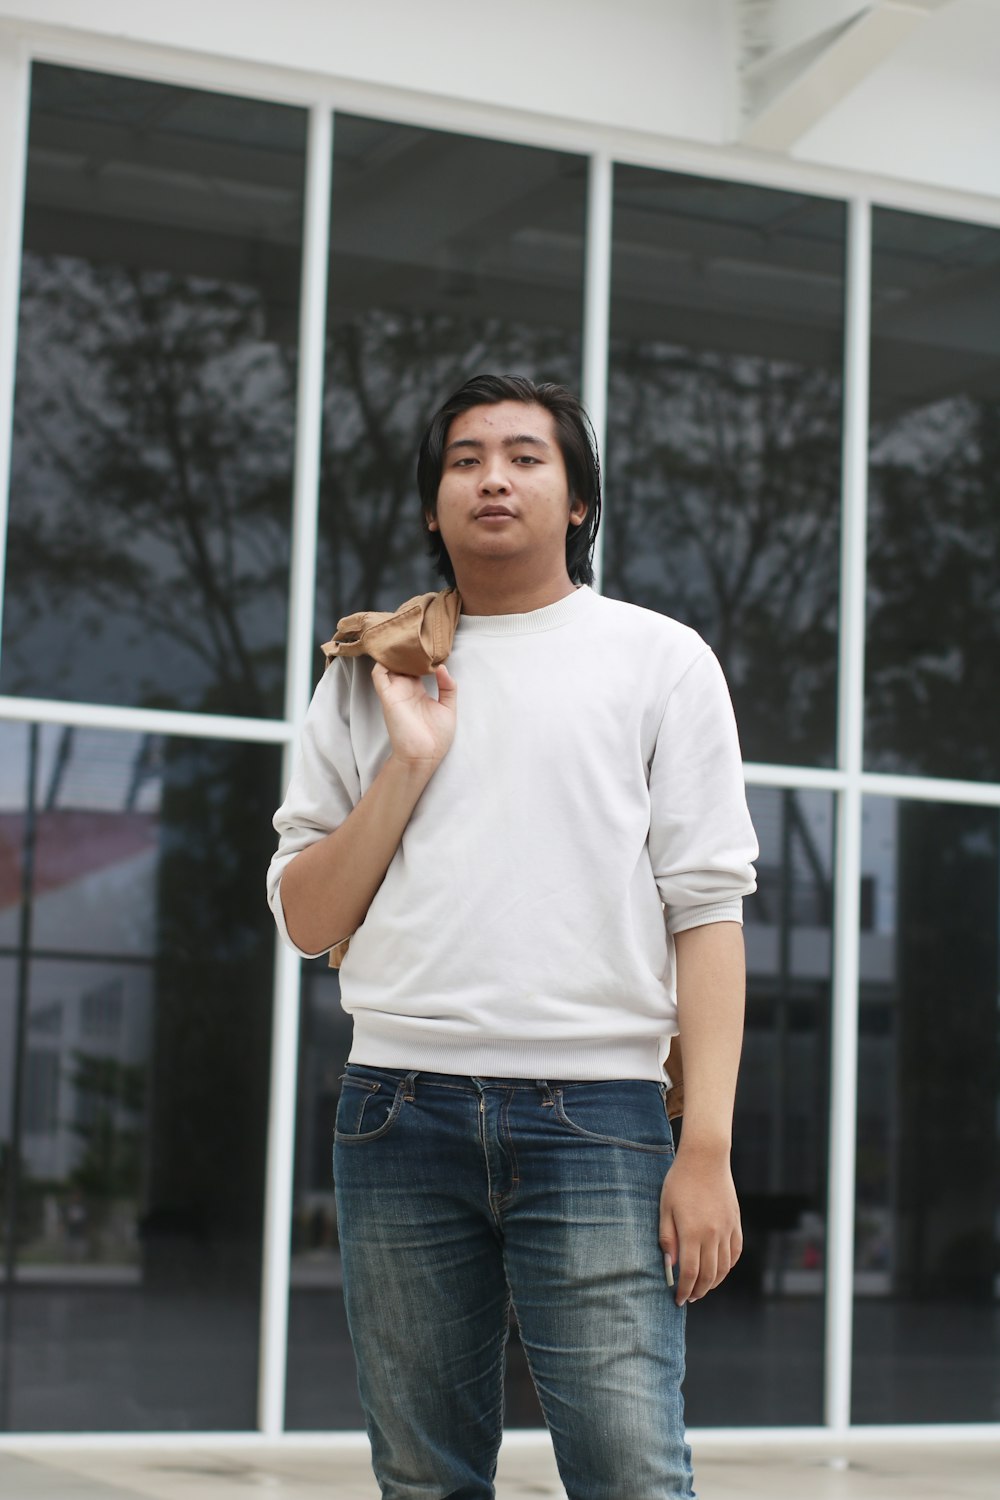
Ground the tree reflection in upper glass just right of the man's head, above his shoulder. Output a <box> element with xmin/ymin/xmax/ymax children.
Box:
<box><xmin>604</xmin><ymin>344</ymin><xmax>841</xmax><ymax>764</ymax></box>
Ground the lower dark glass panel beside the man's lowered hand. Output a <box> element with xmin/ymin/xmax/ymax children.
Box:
<box><xmin>685</xmin><ymin>788</ymin><xmax>834</xmax><ymax>1427</ymax></box>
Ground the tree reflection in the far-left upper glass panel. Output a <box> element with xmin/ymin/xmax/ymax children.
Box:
<box><xmin>4</xmin><ymin>254</ymin><xmax>294</xmax><ymax>714</ymax></box>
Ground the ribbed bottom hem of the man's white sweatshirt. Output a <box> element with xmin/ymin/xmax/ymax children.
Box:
<box><xmin>349</xmin><ymin>1010</ymin><xmax>676</xmax><ymax>1082</ymax></box>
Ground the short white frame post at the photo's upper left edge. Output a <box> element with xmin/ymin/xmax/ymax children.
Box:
<box><xmin>0</xmin><ymin>36</ymin><xmax>31</xmax><ymax>675</ymax></box>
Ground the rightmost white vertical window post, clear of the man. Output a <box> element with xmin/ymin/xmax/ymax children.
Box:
<box><xmin>825</xmin><ymin>200</ymin><xmax>871</xmax><ymax>1433</ymax></box>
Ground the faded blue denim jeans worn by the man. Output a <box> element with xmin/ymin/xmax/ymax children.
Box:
<box><xmin>334</xmin><ymin>1064</ymin><xmax>693</xmax><ymax>1500</ymax></box>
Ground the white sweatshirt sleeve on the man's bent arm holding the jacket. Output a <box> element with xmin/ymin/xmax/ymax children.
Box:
<box><xmin>267</xmin><ymin>660</ymin><xmax>361</xmax><ymax>959</ymax></box>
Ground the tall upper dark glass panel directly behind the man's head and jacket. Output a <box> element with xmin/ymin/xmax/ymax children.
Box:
<box><xmin>316</xmin><ymin>114</ymin><xmax>586</xmax><ymax>641</ymax></box>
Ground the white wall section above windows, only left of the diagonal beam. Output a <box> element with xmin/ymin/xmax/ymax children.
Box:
<box><xmin>0</xmin><ymin>0</ymin><xmax>732</xmax><ymax>141</ymax></box>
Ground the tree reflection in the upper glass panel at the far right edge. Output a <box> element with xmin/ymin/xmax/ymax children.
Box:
<box><xmin>867</xmin><ymin>396</ymin><xmax>1000</xmax><ymax>780</ymax></box>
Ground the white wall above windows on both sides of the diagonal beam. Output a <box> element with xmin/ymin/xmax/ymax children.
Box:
<box><xmin>0</xmin><ymin>0</ymin><xmax>1000</xmax><ymax>200</ymax></box>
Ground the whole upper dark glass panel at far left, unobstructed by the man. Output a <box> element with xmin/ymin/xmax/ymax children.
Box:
<box><xmin>0</xmin><ymin>63</ymin><xmax>304</xmax><ymax>716</ymax></box>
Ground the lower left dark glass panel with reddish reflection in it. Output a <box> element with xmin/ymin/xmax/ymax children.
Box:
<box><xmin>0</xmin><ymin>725</ymin><xmax>280</xmax><ymax>1431</ymax></box>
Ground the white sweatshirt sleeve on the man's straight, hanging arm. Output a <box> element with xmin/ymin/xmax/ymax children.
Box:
<box><xmin>649</xmin><ymin>647</ymin><xmax>757</xmax><ymax>933</ymax></box>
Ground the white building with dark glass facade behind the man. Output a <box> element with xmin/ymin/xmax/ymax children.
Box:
<box><xmin>0</xmin><ymin>0</ymin><xmax>1000</xmax><ymax>1433</ymax></box>
